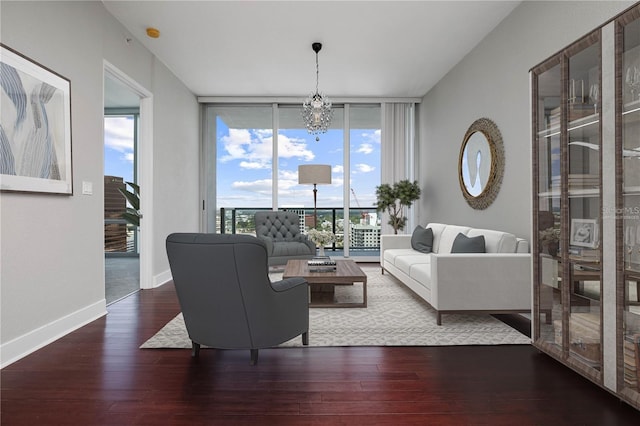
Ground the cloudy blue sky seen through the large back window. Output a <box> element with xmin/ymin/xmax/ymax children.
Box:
<box><xmin>216</xmin><ymin>117</ymin><xmax>380</xmax><ymax>209</ymax></box>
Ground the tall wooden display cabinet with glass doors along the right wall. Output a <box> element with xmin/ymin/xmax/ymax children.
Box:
<box><xmin>531</xmin><ymin>4</ymin><xmax>640</xmax><ymax>409</ymax></box>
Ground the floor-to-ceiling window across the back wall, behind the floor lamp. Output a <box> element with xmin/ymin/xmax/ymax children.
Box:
<box><xmin>204</xmin><ymin>104</ymin><xmax>381</xmax><ymax>256</ymax></box>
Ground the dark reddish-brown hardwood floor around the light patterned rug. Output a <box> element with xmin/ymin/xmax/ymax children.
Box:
<box><xmin>0</xmin><ymin>284</ymin><xmax>640</xmax><ymax>426</ymax></box>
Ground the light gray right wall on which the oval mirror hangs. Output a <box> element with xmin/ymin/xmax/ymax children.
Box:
<box><xmin>418</xmin><ymin>1</ymin><xmax>634</xmax><ymax>240</ymax></box>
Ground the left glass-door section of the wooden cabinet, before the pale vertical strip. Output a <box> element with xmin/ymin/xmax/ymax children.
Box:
<box><xmin>532</xmin><ymin>31</ymin><xmax>602</xmax><ymax>380</ymax></box>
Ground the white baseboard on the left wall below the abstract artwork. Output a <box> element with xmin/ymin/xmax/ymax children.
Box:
<box><xmin>0</xmin><ymin>299</ymin><xmax>107</xmax><ymax>368</ymax></box>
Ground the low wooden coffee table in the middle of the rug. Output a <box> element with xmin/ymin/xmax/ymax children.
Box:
<box><xmin>282</xmin><ymin>259</ymin><xmax>367</xmax><ymax>308</ymax></box>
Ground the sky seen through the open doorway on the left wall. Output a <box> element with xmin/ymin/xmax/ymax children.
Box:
<box><xmin>104</xmin><ymin>116</ymin><xmax>134</xmax><ymax>182</ymax></box>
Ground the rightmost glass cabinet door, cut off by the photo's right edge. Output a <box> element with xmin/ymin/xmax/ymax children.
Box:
<box><xmin>616</xmin><ymin>10</ymin><xmax>640</xmax><ymax>401</ymax></box>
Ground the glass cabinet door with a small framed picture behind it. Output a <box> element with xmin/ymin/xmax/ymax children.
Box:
<box><xmin>563</xmin><ymin>37</ymin><xmax>602</xmax><ymax>370</ymax></box>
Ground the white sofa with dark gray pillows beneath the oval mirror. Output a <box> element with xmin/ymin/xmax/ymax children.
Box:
<box><xmin>380</xmin><ymin>223</ymin><xmax>532</xmax><ymax>325</ymax></box>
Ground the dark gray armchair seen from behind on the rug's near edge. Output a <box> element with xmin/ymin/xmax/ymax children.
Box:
<box><xmin>166</xmin><ymin>233</ymin><xmax>309</xmax><ymax>365</ymax></box>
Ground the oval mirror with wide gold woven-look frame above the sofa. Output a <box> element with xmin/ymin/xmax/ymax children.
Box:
<box><xmin>458</xmin><ymin>118</ymin><xmax>504</xmax><ymax>210</ymax></box>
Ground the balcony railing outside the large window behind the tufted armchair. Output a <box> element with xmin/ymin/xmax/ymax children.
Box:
<box><xmin>216</xmin><ymin>207</ymin><xmax>380</xmax><ymax>255</ymax></box>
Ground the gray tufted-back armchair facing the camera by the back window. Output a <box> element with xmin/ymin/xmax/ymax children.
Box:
<box><xmin>254</xmin><ymin>210</ymin><xmax>316</xmax><ymax>266</ymax></box>
